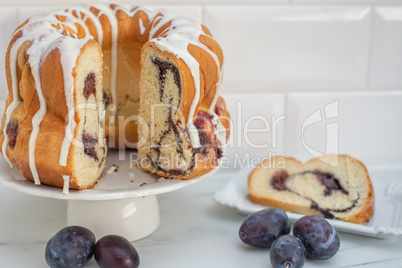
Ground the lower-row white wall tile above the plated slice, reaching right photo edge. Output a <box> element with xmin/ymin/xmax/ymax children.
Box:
<box><xmin>285</xmin><ymin>91</ymin><xmax>402</xmax><ymax>166</ymax></box>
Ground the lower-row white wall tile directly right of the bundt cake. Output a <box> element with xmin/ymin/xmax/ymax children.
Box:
<box><xmin>223</xmin><ymin>93</ymin><xmax>285</xmax><ymax>168</ymax></box>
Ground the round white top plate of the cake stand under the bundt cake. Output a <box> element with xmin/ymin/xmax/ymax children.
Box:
<box><xmin>0</xmin><ymin>150</ymin><xmax>218</xmax><ymax>200</ymax></box>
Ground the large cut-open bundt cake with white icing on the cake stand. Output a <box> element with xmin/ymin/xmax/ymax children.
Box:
<box><xmin>0</xmin><ymin>4</ymin><xmax>230</xmax><ymax>189</ymax></box>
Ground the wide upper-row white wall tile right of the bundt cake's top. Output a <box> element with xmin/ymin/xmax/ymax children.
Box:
<box><xmin>204</xmin><ymin>6</ymin><xmax>371</xmax><ymax>92</ymax></box>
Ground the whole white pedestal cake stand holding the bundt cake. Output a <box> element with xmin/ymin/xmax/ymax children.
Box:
<box><xmin>0</xmin><ymin>150</ymin><xmax>217</xmax><ymax>241</ymax></box>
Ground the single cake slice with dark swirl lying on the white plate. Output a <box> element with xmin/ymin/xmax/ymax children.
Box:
<box><xmin>248</xmin><ymin>154</ymin><xmax>374</xmax><ymax>224</ymax></box>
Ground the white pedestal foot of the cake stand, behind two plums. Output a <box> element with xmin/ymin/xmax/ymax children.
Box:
<box><xmin>67</xmin><ymin>195</ymin><xmax>160</xmax><ymax>241</ymax></box>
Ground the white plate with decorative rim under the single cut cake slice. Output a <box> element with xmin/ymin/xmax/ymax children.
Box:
<box><xmin>214</xmin><ymin>169</ymin><xmax>402</xmax><ymax>238</ymax></box>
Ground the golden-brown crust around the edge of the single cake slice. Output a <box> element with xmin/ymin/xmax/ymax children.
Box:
<box><xmin>247</xmin><ymin>155</ymin><xmax>375</xmax><ymax>224</ymax></box>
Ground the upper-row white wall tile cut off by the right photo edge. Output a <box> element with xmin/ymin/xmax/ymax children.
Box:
<box><xmin>369</xmin><ymin>7</ymin><xmax>402</xmax><ymax>89</ymax></box>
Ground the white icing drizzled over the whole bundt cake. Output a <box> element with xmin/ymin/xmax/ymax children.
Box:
<box><xmin>1</xmin><ymin>4</ymin><xmax>226</xmax><ymax>184</ymax></box>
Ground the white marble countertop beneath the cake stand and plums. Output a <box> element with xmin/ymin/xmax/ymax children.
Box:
<box><xmin>0</xmin><ymin>172</ymin><xmax>402</xmax><ymax>268</ymax></box>
